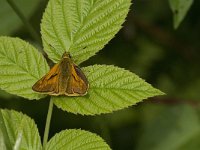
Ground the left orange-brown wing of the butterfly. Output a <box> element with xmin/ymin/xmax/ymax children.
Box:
<box><xmin>32</xmin><ymin>64</ymin><xmax>60</xmax><ymax>95</ymax></box>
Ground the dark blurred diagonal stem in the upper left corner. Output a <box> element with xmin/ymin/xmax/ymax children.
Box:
<box><xmin>7</xmin><ymin>0</ymin><xmax>42</xmax><ymax>45</ymax></box>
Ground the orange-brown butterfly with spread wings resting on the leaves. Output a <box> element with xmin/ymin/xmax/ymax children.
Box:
<box><xmin>32</xmin><ymin>52</ymin><xmax>89</xmax><ymax>96</ymax></box>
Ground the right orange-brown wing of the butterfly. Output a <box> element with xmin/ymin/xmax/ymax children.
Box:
<box><xmin>65</xmin><ymin>64</ymin><xmax>89</xmax><ymax>96</ymax></box>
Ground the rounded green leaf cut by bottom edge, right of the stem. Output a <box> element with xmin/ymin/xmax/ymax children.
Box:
<box><xmin>46</xmin><ymin>129</ymin><xmax>110</xmax><ymax>150</ymax></box>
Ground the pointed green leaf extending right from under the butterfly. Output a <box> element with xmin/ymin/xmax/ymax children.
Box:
<box><xmin>52</xmin><ymin>65</ymin><xmax>163</xmax><ymax>115</ymax></box>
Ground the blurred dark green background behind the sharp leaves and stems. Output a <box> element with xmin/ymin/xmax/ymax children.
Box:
<box><xmin>0</xmin><ymin>0</ymin><xmax>200</xmax><ymax>150</ymax></box>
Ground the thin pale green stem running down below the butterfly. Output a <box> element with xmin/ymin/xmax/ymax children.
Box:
<box><xmin>43</xmin><ymin>99</ymin><xmax>53</xmax><ymax>150</ymax></box>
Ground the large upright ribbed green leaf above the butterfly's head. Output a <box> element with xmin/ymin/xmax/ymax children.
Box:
<box><xmin>41</xmin><ymin>0</ymin><xmax>131</xmax><ymax>64</ymax></box>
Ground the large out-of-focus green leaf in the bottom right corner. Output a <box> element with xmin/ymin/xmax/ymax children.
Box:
<box><xmin>137</xmin><ymin>105</ymin><xmax>200</xmax><ymax>150</ymax></box>
